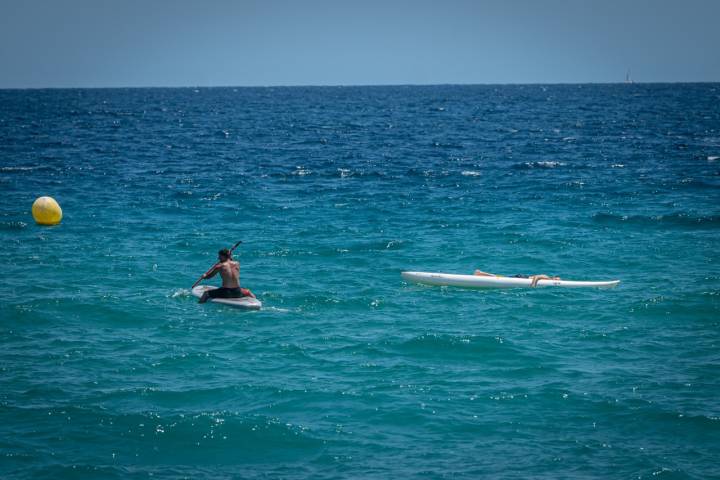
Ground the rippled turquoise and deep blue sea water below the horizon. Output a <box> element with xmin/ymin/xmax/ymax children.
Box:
<box><xmin>0</xmin><ymin>84</ymin><xmax>720</xmax><ymax>479</ymax></box>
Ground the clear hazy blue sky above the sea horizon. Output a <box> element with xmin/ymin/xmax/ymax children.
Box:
<box><xmin>0</xmin><ymin>0</ymin><xmax>720</xmax><ymax>88</ymax></box>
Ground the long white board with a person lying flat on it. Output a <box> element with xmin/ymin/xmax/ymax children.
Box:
<box><xmin>401</xmin><ymin>272</ymin><xmax>620</xmax><ymax>288</ymax></box>
